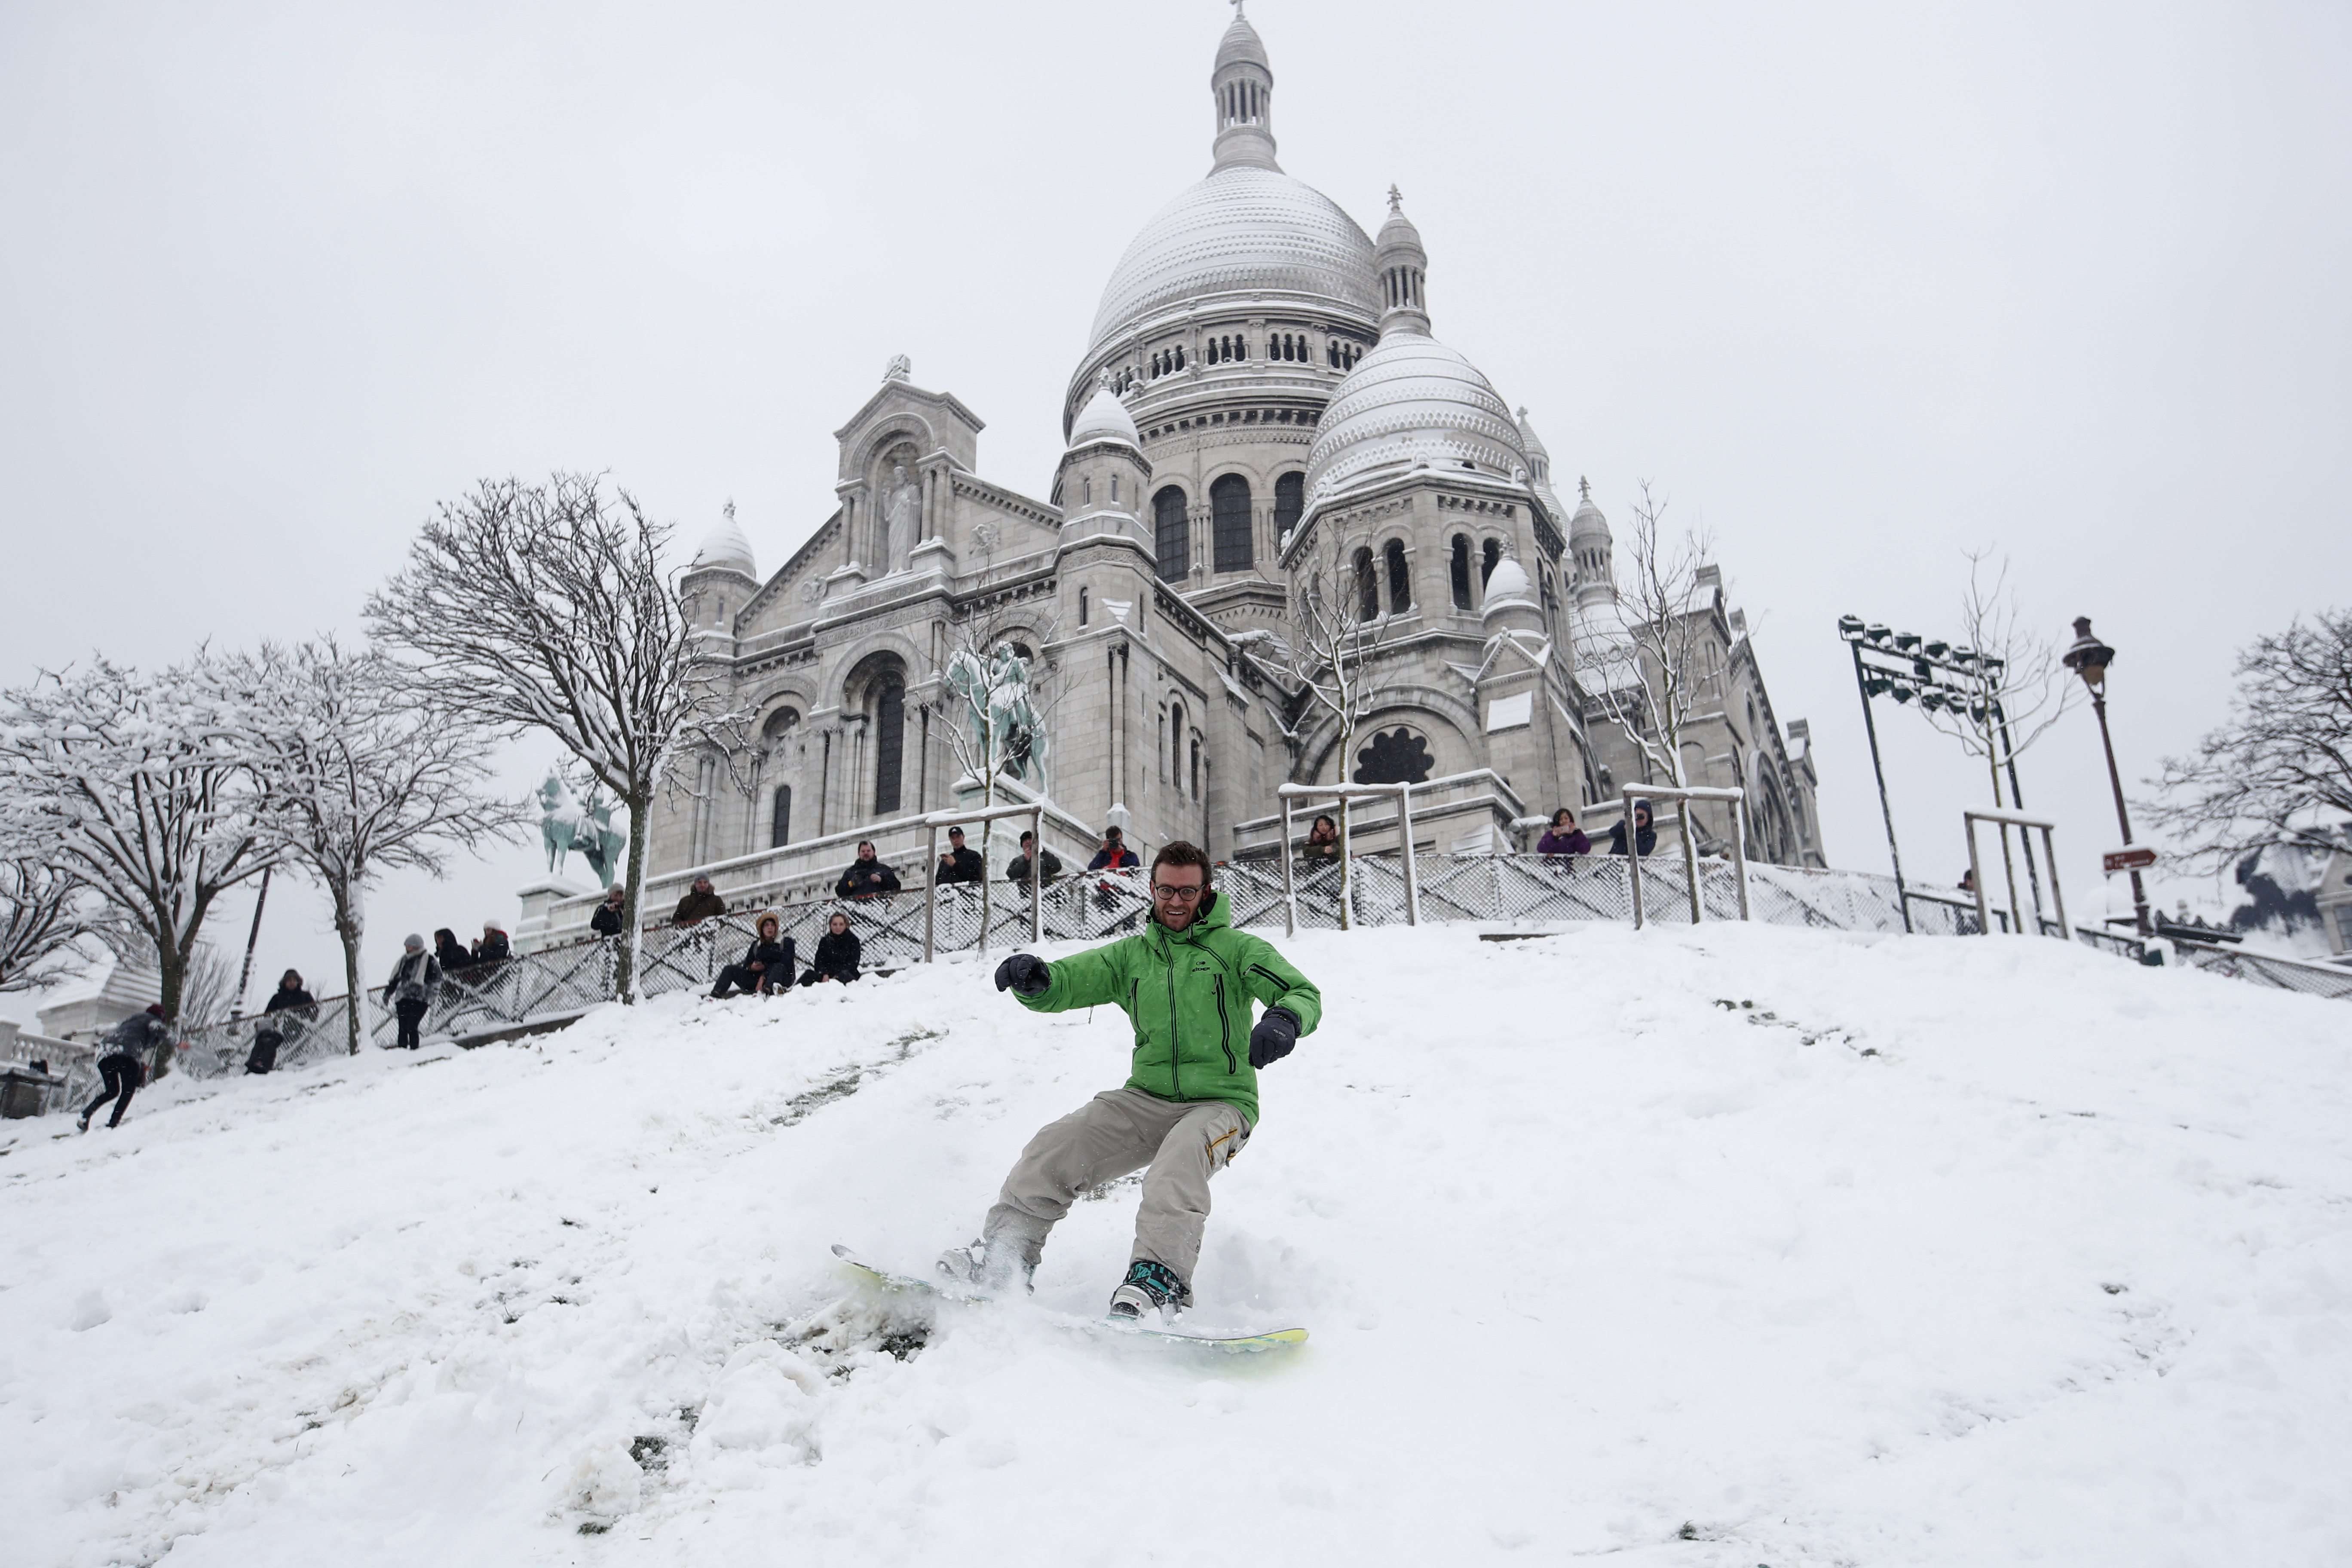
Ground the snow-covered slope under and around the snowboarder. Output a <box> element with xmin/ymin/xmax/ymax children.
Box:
<box><xmin>0</xmin><ymin>926</ymin><xmax>2352</xmax><ymax>1568</ymax></box>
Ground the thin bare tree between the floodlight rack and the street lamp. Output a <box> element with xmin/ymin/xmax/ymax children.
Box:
<box><xmin>1898</xmin><ymin>550</ymin><xmax>2082</xmax><ymax>931</ymax></box>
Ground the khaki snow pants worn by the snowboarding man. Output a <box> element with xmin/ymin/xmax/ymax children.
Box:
<box><xmin>983</xmin><ymin>1086</ymin><xmax>1249</xmax><ymax>1281</ymax></box>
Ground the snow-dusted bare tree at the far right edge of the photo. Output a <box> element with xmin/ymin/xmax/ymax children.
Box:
<box><xmin>2143</xmin><ymin>609</ymin><xmax>2352</xmax><ymax>870</ymax></box>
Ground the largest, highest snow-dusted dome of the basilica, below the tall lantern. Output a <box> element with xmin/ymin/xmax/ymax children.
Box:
<box><xmin>1091</xmin><ymin>167</ymin><xmax>1381</xmax><ymax>343</ymax></box>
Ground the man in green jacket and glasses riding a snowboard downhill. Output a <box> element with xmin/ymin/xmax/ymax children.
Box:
<box><xmin>938</xmin><ymin>842</ymin><xmax>1322</xmax><ymax>1319</ymax></box>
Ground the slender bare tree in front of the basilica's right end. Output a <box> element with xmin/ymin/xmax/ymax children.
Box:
<box><xmin>1576</xmin><ymin>480</ymin><xmax>1738</xmax><ymax>799</ymax></box>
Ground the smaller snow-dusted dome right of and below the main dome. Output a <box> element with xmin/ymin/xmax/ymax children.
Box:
<box><xmin>1308</xmin><ymin>331</ymin><xmax>1526</xmax><ymax>505</ymax></box>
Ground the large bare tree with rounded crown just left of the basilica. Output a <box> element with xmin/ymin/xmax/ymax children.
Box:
<box><xmin>367</xmin><ymin>475</ymin><xmax>743</xmax><ymax>1001</ymax></box>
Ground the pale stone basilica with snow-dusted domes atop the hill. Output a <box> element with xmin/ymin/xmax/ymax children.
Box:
<box><xmin>532</xmin><ymin>6</ymin><xmax>1823</xmax><ymax>928</ymax></box>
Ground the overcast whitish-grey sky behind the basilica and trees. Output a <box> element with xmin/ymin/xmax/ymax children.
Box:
<box><xmin>0</xmin><ymin>0</ymin><xmax>2352</xmax><ymax>1020</ymax></box>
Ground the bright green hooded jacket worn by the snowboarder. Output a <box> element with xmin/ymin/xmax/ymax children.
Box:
<box><xmin>1016</xmin><ymin>888</ymin><xmax>1322</xmax><ymax>1126</ymax></box>
